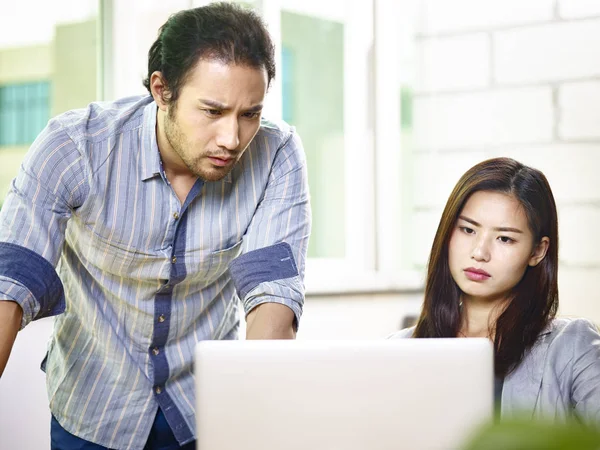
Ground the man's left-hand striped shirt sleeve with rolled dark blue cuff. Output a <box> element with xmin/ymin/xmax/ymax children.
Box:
<box><xmin>0</xmin><ymin>120</ymin><xmax>88</xmax><ymax>328</ymax></box>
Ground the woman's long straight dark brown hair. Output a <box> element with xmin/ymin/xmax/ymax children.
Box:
<box><xmin>413</xmin><ymin>158</ymin><xmax>558</xmax><ymax>377</ymax></box>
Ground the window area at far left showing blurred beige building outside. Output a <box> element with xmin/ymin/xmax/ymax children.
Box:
<box><xmin>0</xmin><ymin>0</ymin><xmax>99</xmax><ymax>204</ymax></box>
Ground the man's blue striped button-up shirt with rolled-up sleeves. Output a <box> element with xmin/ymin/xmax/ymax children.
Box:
<box><xmin>0</xmin><ymin>96</ymin><xmax>311</xmax><ymax>449</ymax></box>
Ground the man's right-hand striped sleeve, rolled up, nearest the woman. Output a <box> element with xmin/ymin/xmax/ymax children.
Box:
<box><xmin>229</xmin><ymin>131</ymin><xmax>311</xmax><ymax>327</ymax></box>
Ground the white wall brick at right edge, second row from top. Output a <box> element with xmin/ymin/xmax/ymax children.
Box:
<box><xmin>494</xmin><ymin>20</ymin><xmax>600</xmax><ymax>83</ymax></box>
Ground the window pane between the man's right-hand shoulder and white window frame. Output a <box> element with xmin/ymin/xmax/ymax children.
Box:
<box><xmin>280</xmin><ymin>10</ymin><xmax>346</xmax><ymax>258</ymax></box>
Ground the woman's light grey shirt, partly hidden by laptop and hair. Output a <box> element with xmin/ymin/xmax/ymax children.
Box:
<box><xmin>390</xmin><ymin>319</ymin><xmax>600</xmax><ymax>424</ymax></box>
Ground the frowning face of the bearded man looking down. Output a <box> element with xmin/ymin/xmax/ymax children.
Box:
<box><xmin>164</xmin><ymin>59</ymin><xmax>268</xmax><ymax>181</ymax></box>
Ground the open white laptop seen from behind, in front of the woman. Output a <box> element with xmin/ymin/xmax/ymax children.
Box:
<box><xmin>195</xmin><ymin>338</ymin><xmax>493</xmax><ymax>450</ymax></box>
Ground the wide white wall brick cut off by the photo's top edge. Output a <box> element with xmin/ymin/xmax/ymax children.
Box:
<box><xmin>419</xmin><ymin>0</ymin><xmax>554</xmax><ymax>34</ymax></box>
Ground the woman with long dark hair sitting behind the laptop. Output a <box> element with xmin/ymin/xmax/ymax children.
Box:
<box><xmin>392</xmin><ymin>158</ymin><xmax>600</xmax><ymax>423</ymax></box>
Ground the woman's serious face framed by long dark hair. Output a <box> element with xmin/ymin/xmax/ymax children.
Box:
<box><xmin>448</xmin><ymin>191</ymin><xmax>549</xmax><ymax>302</ymax></box>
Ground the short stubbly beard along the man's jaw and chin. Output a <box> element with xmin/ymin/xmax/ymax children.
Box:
<box><xmin>164</xmin><ymin>108</ymin><xmax>237</xmax><ymax>181</ymax></box>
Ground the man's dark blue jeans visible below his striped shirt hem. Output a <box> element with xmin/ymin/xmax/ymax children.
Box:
<box><xmin>50</xmin><ymin>408</ymin><xmax>196</xmax><ymax>450</ymax></box>
